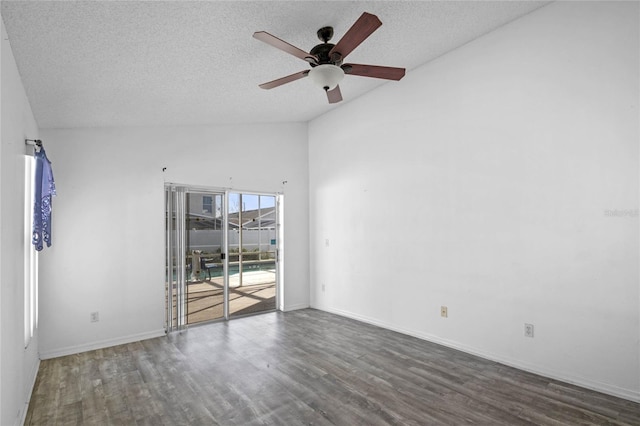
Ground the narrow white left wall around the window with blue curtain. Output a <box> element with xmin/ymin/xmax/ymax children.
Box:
<box><xmin>0</xmin><ymin>17</ymin><xmax>40</xmax><ymax>425</ymax></box>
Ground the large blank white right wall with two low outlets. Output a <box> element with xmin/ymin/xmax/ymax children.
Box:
<box><xmin>309</xmin><ymin>2</ymin><xmax>640</xmax><ymax>400</ymax></box>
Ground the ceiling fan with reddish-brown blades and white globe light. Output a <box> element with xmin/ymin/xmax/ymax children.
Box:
<box><xmin>253</xmin><ymin>12</ymin><xmax>405</xmax><ymax>104</ymax></box>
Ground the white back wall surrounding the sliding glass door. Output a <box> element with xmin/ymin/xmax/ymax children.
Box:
<box><xmin>40</xmin><ymin>124</ymin><xmax>309</xmax><ymax>358</ymax></box>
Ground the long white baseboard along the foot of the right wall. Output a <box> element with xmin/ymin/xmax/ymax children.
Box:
<box><xmin>314</xmin><ymin>307</ymin><xmax>640</xmax><ymax>402</ymax></box>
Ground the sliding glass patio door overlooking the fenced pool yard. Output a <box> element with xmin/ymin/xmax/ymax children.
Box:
<box><xmin>165</xmin><ymin>184</ymin><xmax>278</xmax><ymax>331</ymax></box>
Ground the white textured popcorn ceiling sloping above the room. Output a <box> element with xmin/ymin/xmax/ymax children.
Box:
<box><xmin>2</xmin><ymin>1</ymin><xmax>547</xmax><ymax>128</ymax></box>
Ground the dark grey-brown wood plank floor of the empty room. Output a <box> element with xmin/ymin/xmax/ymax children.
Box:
<box><xmin>26</xmin><ymin>309</ymin><xmax>640</xmax><ymax>426</ymax></box>
